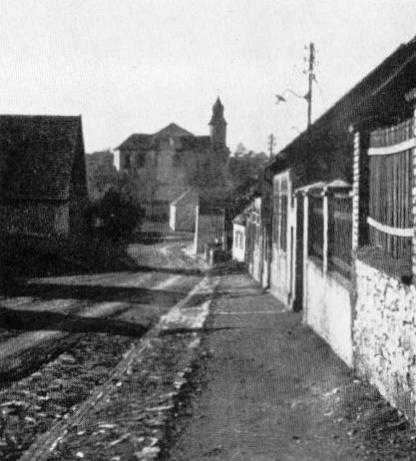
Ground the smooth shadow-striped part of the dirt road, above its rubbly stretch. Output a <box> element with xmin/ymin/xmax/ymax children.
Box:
<box><xmin>0</xmin><ymin>237</ymin><xmax>201</xmax><ymax>384</ymax></box>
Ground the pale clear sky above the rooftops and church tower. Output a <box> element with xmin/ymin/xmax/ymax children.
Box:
<box><xmin>0</xmin><ymin>0</ymin><xmax>416</xmax><ymax>152</ymax></box>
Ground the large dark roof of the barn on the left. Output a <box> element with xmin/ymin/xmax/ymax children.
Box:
<box><xmin>0</xmin><ymin>115</ymin><xmax>83</xmax><ymax>200</ymax></box>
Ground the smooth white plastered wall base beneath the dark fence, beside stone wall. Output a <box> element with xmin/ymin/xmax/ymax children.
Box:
<box><xmin>303</xmin><ymin>260</ymin><xmax>353</xmax><ymax>367</ymax></box>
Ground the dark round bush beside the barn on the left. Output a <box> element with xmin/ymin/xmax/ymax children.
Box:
<box><xmin>87</xmin><ymin>190</ymin><xmax>145</xmax><ymax>240</ymax></box>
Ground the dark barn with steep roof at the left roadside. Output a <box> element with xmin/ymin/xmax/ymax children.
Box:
<box><xmin>0</xmin><ymin>115</ymin><xmax>88</xmax><ymax>237</ymax></box>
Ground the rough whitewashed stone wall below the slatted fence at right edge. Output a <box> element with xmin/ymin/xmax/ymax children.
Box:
<box><xmin>353</xmin><ymin>260</ymin><xmax>416</xmax><ymax>420</ymax></box>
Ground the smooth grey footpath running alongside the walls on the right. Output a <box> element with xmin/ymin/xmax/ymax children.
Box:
<box><xmin>164</xmin><ymin>274</ymin><xmax>416</xmax><ymax>461</ymax></box>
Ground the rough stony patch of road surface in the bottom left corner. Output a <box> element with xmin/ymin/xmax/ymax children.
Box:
<box><xmin>0</xmin><ymin>334</ymin><xmax>139</xmax><ymax>460</ymax></box>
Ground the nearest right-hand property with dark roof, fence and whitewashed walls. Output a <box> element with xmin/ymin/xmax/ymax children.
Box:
<box><xmin>236</xmin><ymin>39</ymin><xmax>416</xmax><ymax>421</ymax></box>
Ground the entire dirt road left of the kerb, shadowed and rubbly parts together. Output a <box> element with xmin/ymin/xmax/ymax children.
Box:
<box><xmin>0</xmin><ymin>237</ymin><xmax>203</xmax><ymax>460</ymax></box>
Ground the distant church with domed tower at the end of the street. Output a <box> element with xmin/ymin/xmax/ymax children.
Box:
<box><xmin>116</xmin><ymin>98</ymin><xmax>229</xmax><ymax>220</ymax></box>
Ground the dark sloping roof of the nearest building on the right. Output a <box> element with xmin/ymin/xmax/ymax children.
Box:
<box><xmin>276</xmin><ymin>38</ymin><xmax>416</xmax><ymax>169</ymax></box>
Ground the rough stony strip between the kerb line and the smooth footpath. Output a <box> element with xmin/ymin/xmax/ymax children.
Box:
<box><xmin>23</xmin><ymin>279</ymin><xmax>215</xmax><ymax>461</ymax></box>
